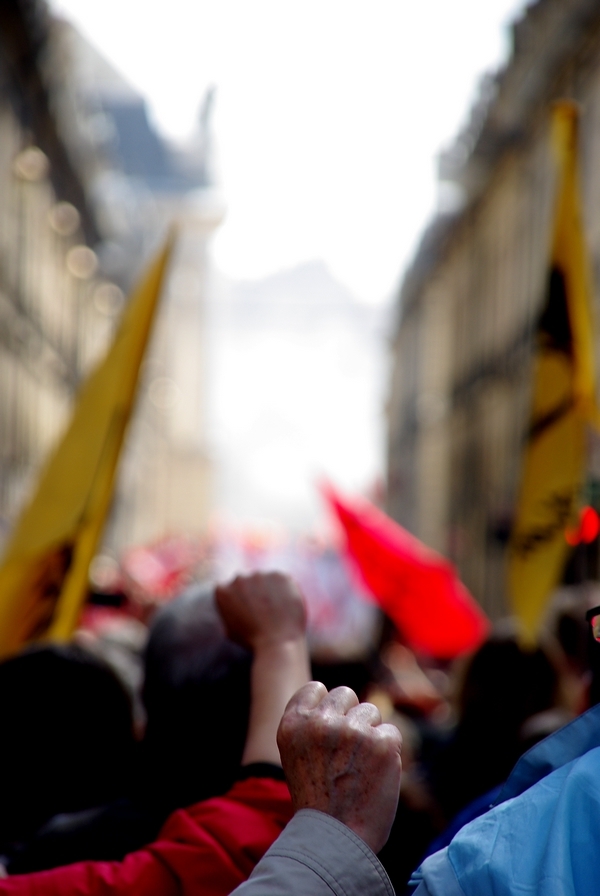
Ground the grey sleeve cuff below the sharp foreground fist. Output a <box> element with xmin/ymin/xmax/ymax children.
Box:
<box><xmin>232</xmin><ymin>809</ymin><xmax>395</xmax><ymax>896</ymax></box>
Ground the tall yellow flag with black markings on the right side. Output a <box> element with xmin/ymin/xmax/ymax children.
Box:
<box><xmin>508</xmin><ymin>101</ymin><xmax>597</xmax><ymax>643</ymax></box>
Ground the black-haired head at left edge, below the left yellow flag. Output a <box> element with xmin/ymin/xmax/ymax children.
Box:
<box><xmin>0</xmin><ymin>645</ymin><xmax>134</xmax><ymax>843</ymax></box>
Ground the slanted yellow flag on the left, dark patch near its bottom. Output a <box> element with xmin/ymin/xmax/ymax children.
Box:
<box><xmin>0</xmin><ymin>238</ymin><xmax>173</xmax><ymax>657</ymax></box>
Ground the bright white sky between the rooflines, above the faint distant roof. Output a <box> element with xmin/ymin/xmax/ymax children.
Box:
<box><xmin>52</xmin><ymin>0</ymin><xmax>524</xmax><ymax>302</ymax></box>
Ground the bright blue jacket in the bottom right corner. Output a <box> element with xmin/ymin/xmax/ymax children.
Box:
<box><xmin>411</xmin><ymin>706</ymin><xmax>600</xmax><ymax>896</ymax></box>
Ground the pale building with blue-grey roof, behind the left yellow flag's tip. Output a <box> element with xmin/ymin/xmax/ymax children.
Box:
<box><xmin>53</xmin><ymin>22</ymin><xmax>223</xmax><ymax>554</ymax></box>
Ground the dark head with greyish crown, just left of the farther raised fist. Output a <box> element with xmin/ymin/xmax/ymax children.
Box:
<box><xmin>143</xmin><ymin>586</ymin><xmax>251</xmax><ymax>811</ymax></box>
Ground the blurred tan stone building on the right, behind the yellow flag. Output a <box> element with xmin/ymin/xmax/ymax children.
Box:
<box><xmin>388</xmin><ymin>0</ymin><xmax>600</xmax><ymax>617</ymax></box>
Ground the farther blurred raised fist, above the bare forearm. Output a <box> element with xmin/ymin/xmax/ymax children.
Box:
<box><xmin>215</xmin><ymin>572</ymin><xmax>306</xmax><ymax>652</ymax></box>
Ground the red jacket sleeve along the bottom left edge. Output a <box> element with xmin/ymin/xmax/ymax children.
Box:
<box><xmin>0</xmin><ymin>778</ymin><xmax>292</xmax><ymax>896</ymax></box>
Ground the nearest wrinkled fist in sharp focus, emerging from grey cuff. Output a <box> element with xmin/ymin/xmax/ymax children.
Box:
<box><xmin>277</xmin><ymin>681</ymin><xmax>402</xmax><ymax>852</ymax></box>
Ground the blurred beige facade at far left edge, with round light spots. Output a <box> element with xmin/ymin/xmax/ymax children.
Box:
<box><xmin>0</xmin><ymin>0</ymin><xmax>111</xmax><ymax>541</ymax></box>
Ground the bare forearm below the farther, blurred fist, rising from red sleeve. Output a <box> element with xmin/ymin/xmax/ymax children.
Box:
<box><xmin>242</xmin><ymin>637</ymin><xmax>310</xmax><ymax>765</ymax></box>
